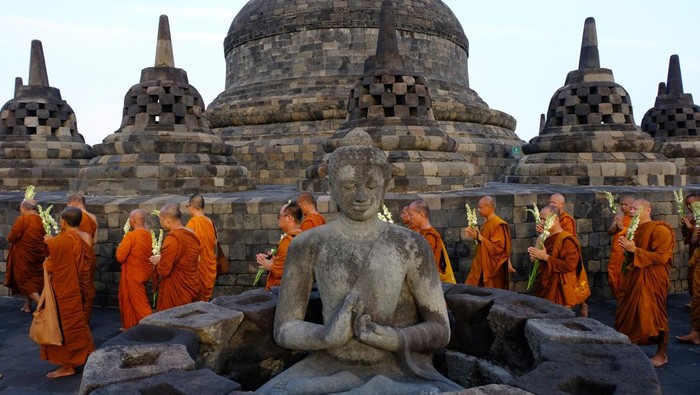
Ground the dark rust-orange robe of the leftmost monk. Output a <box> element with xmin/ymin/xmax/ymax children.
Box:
<box><xmin>5</xmin><ymin>213</ymin><xmax>46</xmax><ymax>295</ymax></box>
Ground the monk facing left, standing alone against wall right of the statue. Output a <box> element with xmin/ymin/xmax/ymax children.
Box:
<box><xmin>464</xmin><ymin>196</ymin><xmax>512</xmax><ymax>290</ymax></box>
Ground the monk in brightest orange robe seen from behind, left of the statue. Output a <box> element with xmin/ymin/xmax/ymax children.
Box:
<box><xmin>187</xmin><ymin>194</ymin><xmax>217</xmax><ymax>302</ymax></box>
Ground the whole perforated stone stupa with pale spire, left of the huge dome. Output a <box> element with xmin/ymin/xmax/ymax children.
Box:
<box><xmin>74</xmin><ymin>15</ymin><xmax>254</xmax><ymax>195</ymax></box>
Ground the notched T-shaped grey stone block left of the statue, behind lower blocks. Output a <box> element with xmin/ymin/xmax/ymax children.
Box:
<box><xmin>141</xmin><ymin>302</ymin><xmax>243</xmax><ymax>373</ymax></box>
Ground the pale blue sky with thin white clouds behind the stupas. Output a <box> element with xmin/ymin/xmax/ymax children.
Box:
<box><xmin>0</xmin><ymin>0</ymin><xmax>700</xmax><ymax>145</ymax></box>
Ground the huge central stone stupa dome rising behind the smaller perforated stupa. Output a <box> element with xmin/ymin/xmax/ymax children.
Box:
<box><xmin>207</xmin><ymin>0</ymin><xmax>523</xmax><ymax>184</ymax></box>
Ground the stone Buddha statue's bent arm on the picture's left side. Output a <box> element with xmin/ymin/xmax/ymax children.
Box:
<box><xmin>274</xmin><ymin>243</ymin><xmax>357</xmax><ymax>350</ymax></box>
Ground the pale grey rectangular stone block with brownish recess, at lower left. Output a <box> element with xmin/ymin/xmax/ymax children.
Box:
<box><xmin>79</xmin><ymin>344</ymin><xmax>194</xmax><ymax>395</ymax></box>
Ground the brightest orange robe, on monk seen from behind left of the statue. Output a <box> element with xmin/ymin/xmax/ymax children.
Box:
<box><xmin>187</xmin><ymin>217</ymin><xmax>216</xmax><ymax>302</ymax></box>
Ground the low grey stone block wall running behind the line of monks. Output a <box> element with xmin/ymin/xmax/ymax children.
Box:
<box><xmin>0</xmin><ymin>183</ymin><xmax>700</xmax><ymax>306</ymax></box>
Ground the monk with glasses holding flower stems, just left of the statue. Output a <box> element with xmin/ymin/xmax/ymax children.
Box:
<box><xmin>255</xmin><ymin>202</ymin><xmax>302</xmax><ymax>291</ymax></box>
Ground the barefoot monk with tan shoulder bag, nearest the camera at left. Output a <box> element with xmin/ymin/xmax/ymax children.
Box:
<box><xmin>40</xmin><ymin>207</ymin><xmax>95</xmax><ymax>379</ymax></box>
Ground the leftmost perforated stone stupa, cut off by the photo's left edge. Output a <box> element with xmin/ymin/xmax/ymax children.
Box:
<box><xmin>0</xmin><ymin>40</ymin><xmax>95</xmax><ymax>191</ymax></box>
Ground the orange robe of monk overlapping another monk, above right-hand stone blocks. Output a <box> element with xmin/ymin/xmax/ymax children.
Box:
<box><xmin>535</xmin><ymin>231</ymin><xmax>581</xmax><ymax>307</ymax></box>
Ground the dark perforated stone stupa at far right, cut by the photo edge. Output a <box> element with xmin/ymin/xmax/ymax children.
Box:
<box><xmin>641</xmin><ymin>55</ymin><xmax>700</xmax><ymax>184</ymax></box>
